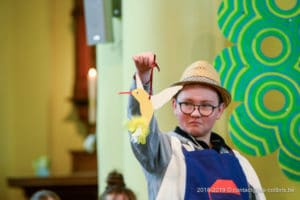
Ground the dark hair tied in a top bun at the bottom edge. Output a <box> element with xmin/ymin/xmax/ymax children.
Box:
<box><xmin>100</xmin><ymin>170</ymin><xmax>136</xmax><ymax>200</ymax></box>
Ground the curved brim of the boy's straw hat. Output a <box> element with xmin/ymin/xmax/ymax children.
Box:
<box><xmin>171</xmin><ymin>80</ymin><xmax>231</xmax><ymax>107</ymax></box>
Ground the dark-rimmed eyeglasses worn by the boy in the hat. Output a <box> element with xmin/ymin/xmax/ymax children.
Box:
<box><xmin>177</xmin><ymin>102</ymin><xmax>219</xmax><ymax>117</ymax></box>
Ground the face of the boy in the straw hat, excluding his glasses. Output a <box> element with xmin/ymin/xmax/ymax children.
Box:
<box><xmin>172</xmin><ymin>84</ymin><xmax>224</xmax><ymax>139</ymax></box>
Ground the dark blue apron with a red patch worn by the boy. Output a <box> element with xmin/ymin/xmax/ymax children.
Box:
<box><xmin>183</xmin><ymin>148</ymin><xmax>249</xmax><ymax>200</ymax></box>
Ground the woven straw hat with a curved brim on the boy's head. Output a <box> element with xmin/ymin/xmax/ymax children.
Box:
<box><xmin>172</xmin><ymin>60</ymin><xmax>231</xmax><ymax>107</ymax></box>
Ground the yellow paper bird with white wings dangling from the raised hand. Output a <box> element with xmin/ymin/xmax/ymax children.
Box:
<box><xmin>120</xmin><ymin>73</ymin><xmax>182</xmax><ymax>144</ymax></box>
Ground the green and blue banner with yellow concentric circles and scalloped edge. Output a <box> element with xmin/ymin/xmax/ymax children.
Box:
<box><xmin>214</xmin><ymin>0</ymin><xmax>300</xmax><ymax>181</ymax></box>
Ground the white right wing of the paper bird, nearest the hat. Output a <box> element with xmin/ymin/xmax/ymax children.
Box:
<box><xmin>151</xmin><ymin>85</ymin><xmax>182</xmax><ymax>110</ymax></box>
